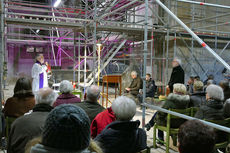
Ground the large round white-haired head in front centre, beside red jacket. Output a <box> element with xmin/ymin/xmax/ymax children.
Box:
<box><xmin>112</xmin><ymin>96</ymin><xmax>136</xmax><ymax>121</ymax></box>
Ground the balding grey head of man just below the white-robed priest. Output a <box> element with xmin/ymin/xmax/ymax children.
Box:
<box><xmin>35</xmin><ymin>87</ymin><xmax>58</xmax><ymax>106</ymax></box>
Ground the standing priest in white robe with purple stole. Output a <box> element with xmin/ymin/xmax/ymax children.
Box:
<box><xmin>32</xmin><ymin>54</ymin><xmax>48</xmax><ymax>93</ymax></box>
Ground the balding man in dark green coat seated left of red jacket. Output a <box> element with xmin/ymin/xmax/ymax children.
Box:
<box><xmin>75</xmin><ymin>85</ymin><xmax>105</xmax><ymax>124</ymax></box>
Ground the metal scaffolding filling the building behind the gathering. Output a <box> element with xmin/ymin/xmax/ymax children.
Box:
<box><xmin>0</xmin><ymin>0</ymin><xmax>230</xmax><ymax>124</ymax></box>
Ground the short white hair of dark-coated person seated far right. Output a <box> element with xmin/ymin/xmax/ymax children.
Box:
<box><xmin>206</xmin><ymin>84</ymin><xmax>224</xmax><ymax>101</ymax></box>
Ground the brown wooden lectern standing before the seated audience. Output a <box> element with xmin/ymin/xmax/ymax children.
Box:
<box><xmin>102</xmin><ymin>75</ymin><xmax>122</xmax><ymax>108</ymax></box>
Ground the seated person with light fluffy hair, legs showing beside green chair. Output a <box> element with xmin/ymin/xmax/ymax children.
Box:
<box><xmin>145</xmin><ymin>83</ymin><xmax>190</xmax><ymax>140</ymax></box>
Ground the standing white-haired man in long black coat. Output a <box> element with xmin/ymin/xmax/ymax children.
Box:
<box><xmin>167</xmin><ymin>58</ymin><xmax>184</xmax><ymax>92</ymax></box>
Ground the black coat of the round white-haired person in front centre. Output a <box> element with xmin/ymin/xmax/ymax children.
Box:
<box><xmin>95</xmin><ymin>121</ymin><xmax>147</xmax><ymax>153</ymax></box>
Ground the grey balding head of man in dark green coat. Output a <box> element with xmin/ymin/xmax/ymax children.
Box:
<box><xmin>86</xmin><ymin>85</ymin><xmax>101</xmax><ymax>101</ymax></box>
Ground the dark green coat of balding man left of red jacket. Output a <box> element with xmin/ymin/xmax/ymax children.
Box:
<box><xmin>74</xmin><ymin>100</ymin><xmax>105</xmax><ymax>123</ymax></box>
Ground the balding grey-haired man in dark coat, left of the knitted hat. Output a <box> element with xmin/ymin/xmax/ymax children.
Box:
<box><xmin>7</xmin><ymin>88</ymin><xmax>57</xmax><ymax>153</ymax></box>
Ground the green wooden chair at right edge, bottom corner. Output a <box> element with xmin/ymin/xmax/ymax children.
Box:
<box><xmin>205</xmin><ymin>118</ymin><xmax>230</xmax><ymax>149</ymax></box>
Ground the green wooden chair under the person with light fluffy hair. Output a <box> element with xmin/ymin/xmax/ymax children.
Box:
<box><xmin>153</xmin><ymin>108</ymin><xmax>191</xmax><ymax>153</ymax></box>
